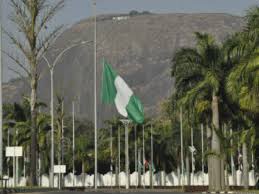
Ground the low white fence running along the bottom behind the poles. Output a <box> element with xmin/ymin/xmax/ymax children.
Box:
<box><xmin>7</xmin><ymin>170</ymin><xmax>256</xmax><ymax>187</ymax></box>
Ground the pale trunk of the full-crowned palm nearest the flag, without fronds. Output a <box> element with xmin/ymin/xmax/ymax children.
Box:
<box><xmin>209</xmin><ymin>94</ymin><xmax>225</xmax><ymax>191</ymax></box>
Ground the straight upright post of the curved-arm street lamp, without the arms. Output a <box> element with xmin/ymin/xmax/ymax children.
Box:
<box><xmin>50</xmin><ymin>68</ymin><xmax>54</xmax><ymax>188</ymax></box>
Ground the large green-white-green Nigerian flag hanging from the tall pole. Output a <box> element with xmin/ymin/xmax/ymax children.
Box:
<box><xmin>102</xmin><ymin>62</ymin><xmax>144</xmax><ymax>124</ymax></box>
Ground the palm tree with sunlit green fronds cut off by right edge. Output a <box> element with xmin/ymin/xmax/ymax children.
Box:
<box><xmin>226</xmin><ymin>6</ymin><xmax>259</xmax><ymax>189</ymax></box>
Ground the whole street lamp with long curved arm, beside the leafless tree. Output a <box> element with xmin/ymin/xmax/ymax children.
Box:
<box><xmin>43</xmin><ymin>41</ymin><xmax>93</xmax><ymax>187</ymax></box>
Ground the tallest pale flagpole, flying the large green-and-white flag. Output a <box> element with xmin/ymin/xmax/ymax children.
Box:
<box><xmin>93</xmin><ymin>0</ymin><xmax>97</xmax><ymax>189</ymax></box>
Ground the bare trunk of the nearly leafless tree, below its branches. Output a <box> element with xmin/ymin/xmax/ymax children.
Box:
<box><xmin>30</xmin><ymin>73</ymin><xmax>37</xmax><ymax>186</ymax></box>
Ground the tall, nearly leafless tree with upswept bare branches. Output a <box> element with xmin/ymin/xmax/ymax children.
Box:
<box><xmin>5</xmin><ymin>0</ymin><xmax>64</xmax><ymax>185</ymax></box>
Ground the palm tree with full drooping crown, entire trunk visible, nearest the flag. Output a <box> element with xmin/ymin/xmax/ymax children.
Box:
<box><xmin>172</xmin><ymin>33</ymin><xmax>228</xmax><ymax>191</ymax></box>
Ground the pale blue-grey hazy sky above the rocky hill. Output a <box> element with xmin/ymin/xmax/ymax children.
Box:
<box><xmin>2</xmin><ymin>0</ymin><xmax>259</xmax><ymax>81</ymax></box>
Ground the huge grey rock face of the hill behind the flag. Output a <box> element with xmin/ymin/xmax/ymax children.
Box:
<box><xmin>4</xmin><ymin>14</ymin><xmax>244</xmax><ymax>124</ymax></box>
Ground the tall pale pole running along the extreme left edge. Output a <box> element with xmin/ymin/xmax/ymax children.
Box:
<box><xmin>0</xmin><ymin>1</ymin><xmax>3</xmax><ymax>177</ymax></box>
